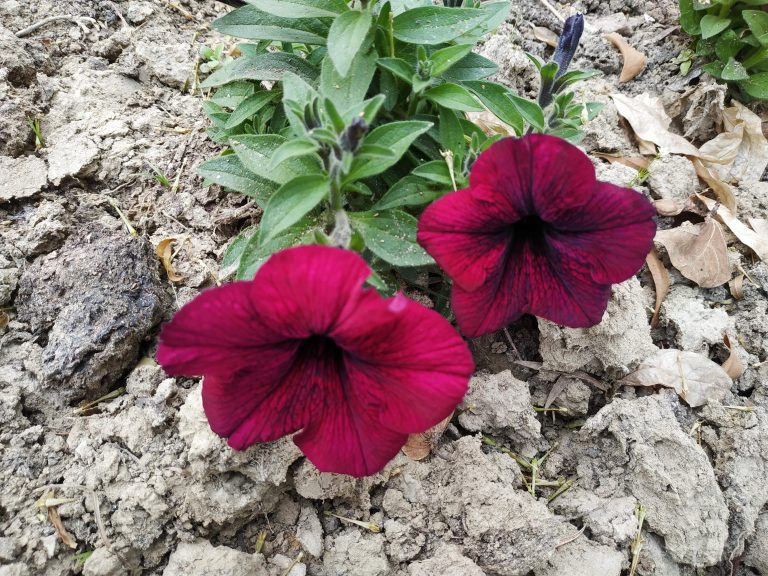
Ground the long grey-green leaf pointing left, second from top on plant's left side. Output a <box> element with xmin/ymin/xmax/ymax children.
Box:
<box><xmin>201</xmin><ymin>52</ymin><xmax>317</xmax><ymax>88</ymax></box>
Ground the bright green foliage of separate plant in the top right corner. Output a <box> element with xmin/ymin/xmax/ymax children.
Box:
<box><xmin>679</xmin><ymin>0</ymin><xmax>768</xmax><ymax>100</ymax></box>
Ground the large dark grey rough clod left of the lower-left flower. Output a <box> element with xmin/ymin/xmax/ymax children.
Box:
<box><xmin>16</xmin><ymin>225</ymin><xmax>168</xmax><ymax>401</ymax></box>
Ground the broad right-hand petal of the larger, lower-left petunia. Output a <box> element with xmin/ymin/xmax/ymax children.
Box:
<box><xmin>333</xmin><ymin>293</ymin><xmax>474</xmax><ymax>434</ymax></box>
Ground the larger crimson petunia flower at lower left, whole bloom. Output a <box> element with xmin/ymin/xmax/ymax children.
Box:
<box><xmin>157</xmin><ymin>246</ymin><xmax>473</xmax><ymax>476</ymax></box>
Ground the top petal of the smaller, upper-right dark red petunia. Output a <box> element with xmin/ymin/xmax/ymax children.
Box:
<box><xmin>470</xmin><ymin>134</ymin><xmax>596</xmax><ymax>222</ymax></box>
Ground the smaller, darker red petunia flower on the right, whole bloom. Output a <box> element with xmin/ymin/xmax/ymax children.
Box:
<box><xmin>418</xmin><ymin>135</ymin><xmax>656</xmax><ymax>337</ymax></box>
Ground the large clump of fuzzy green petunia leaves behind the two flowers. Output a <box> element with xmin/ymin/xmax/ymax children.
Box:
<box><xmin>199</xmin><ymin>0</ymin><xmax>596</xmax><ymax>292</ymax></box>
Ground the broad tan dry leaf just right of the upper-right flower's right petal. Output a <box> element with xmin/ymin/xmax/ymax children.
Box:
<box><xmin>655</xmin><ymin>218</ymin><xmax>731</xmax><ymax>288</ymax></box>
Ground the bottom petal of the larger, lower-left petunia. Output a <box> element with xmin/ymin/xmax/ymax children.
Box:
<box><xmin>293</xmin><ymin>400</ymin><xmax>408</xmax><ymax>477</ymax></box>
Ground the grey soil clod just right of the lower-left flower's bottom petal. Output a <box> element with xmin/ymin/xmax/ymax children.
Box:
<box><xmin>459</xmin><ymin>370</ymin><xmax>546</xmax><ymax>456</ymax></box>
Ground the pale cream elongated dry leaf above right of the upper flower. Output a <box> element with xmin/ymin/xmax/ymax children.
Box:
<box><xmin>611</xmin><ymin>93</ymin><xmax>700</xmax><ymax>156</ymax></box>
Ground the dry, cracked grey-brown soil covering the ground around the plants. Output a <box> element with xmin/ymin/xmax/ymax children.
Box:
<box><xmin>0</xmin><ymin>0</ymin><xmax>768</xmax><ymax>576</ymax></box>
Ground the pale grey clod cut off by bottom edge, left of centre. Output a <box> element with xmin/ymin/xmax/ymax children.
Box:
<box><xmin>163</xmin><ymin>540</ymin><xmax>267</xmax><ymax>576</ymax></box>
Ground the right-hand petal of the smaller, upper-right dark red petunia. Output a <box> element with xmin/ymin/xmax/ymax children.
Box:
<box><xmin>548</xmin><ymin>183</ymin><xmax>656</xmax><ymax>284</ymax></box>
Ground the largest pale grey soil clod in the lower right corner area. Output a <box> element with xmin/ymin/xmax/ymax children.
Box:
<box><xmin>577</xmin><ymin>391</ymin><xmax>728</xmax><ymax>567</ymax></box>
